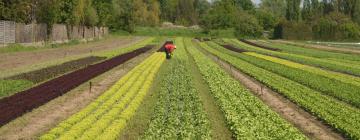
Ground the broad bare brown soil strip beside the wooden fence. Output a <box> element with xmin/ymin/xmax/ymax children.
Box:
<box><xmin>0</xmin><ymin>37</ymin><xmax>143</xmax><ymax>71</ymax></box>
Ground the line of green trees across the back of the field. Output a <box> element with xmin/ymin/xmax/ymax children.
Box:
<box><xmin>0</xmin><ymin>0</ymin><xmax>360</xmax><ymax>40</ymax></box>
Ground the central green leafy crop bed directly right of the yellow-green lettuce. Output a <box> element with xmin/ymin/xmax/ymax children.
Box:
<box><xmin>142</xmin><ymin>38</ymin><xmax>210</xmax><ymax>140</ymax></box>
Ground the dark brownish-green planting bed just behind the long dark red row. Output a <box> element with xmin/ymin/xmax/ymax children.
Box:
<box><xmin>6</xmin><ymin>56</ymin><xmax>105</xmax><ymax>83</ymax></box>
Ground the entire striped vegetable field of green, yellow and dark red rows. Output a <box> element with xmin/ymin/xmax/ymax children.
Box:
<box><xmin>0</xmin><ymin>37</ymin><xmax>360</xmax><ymax>140</ymax></box>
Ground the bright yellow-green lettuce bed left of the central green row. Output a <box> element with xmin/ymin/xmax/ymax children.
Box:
<box><xmin>40</xmin><ymin>53</ymin><xmax>164</xmax><ymax>140</ymax></box>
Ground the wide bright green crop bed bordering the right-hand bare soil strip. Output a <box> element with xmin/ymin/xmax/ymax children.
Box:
<box><xmin>186</xmin><ymin>39</ymin><xmax>306</xmax><ymax>139</ymax></box>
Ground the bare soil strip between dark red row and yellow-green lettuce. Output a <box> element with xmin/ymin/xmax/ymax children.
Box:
<box><xmin>0</xmin><ymin>49</ymin><xmax>155</xmax><ymax>140</ymax></box>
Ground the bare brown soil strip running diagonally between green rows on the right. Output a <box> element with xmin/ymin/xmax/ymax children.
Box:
<box><xmin>201</xmin><ymin>43</ymin><xmax>344</xmax><ymax>140</ymax></box>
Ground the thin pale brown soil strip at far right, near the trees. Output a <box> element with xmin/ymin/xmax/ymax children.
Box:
<box><xmin>272</xmin><ymin>40</ymin><xmax>360</xmax><ymax>54</ymax></box>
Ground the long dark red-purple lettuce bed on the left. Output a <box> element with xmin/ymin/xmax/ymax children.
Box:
<box><xmin>0</xmin><ymin>47</ymin><xmax>151</xmax><ymax>125</ymax></box>
